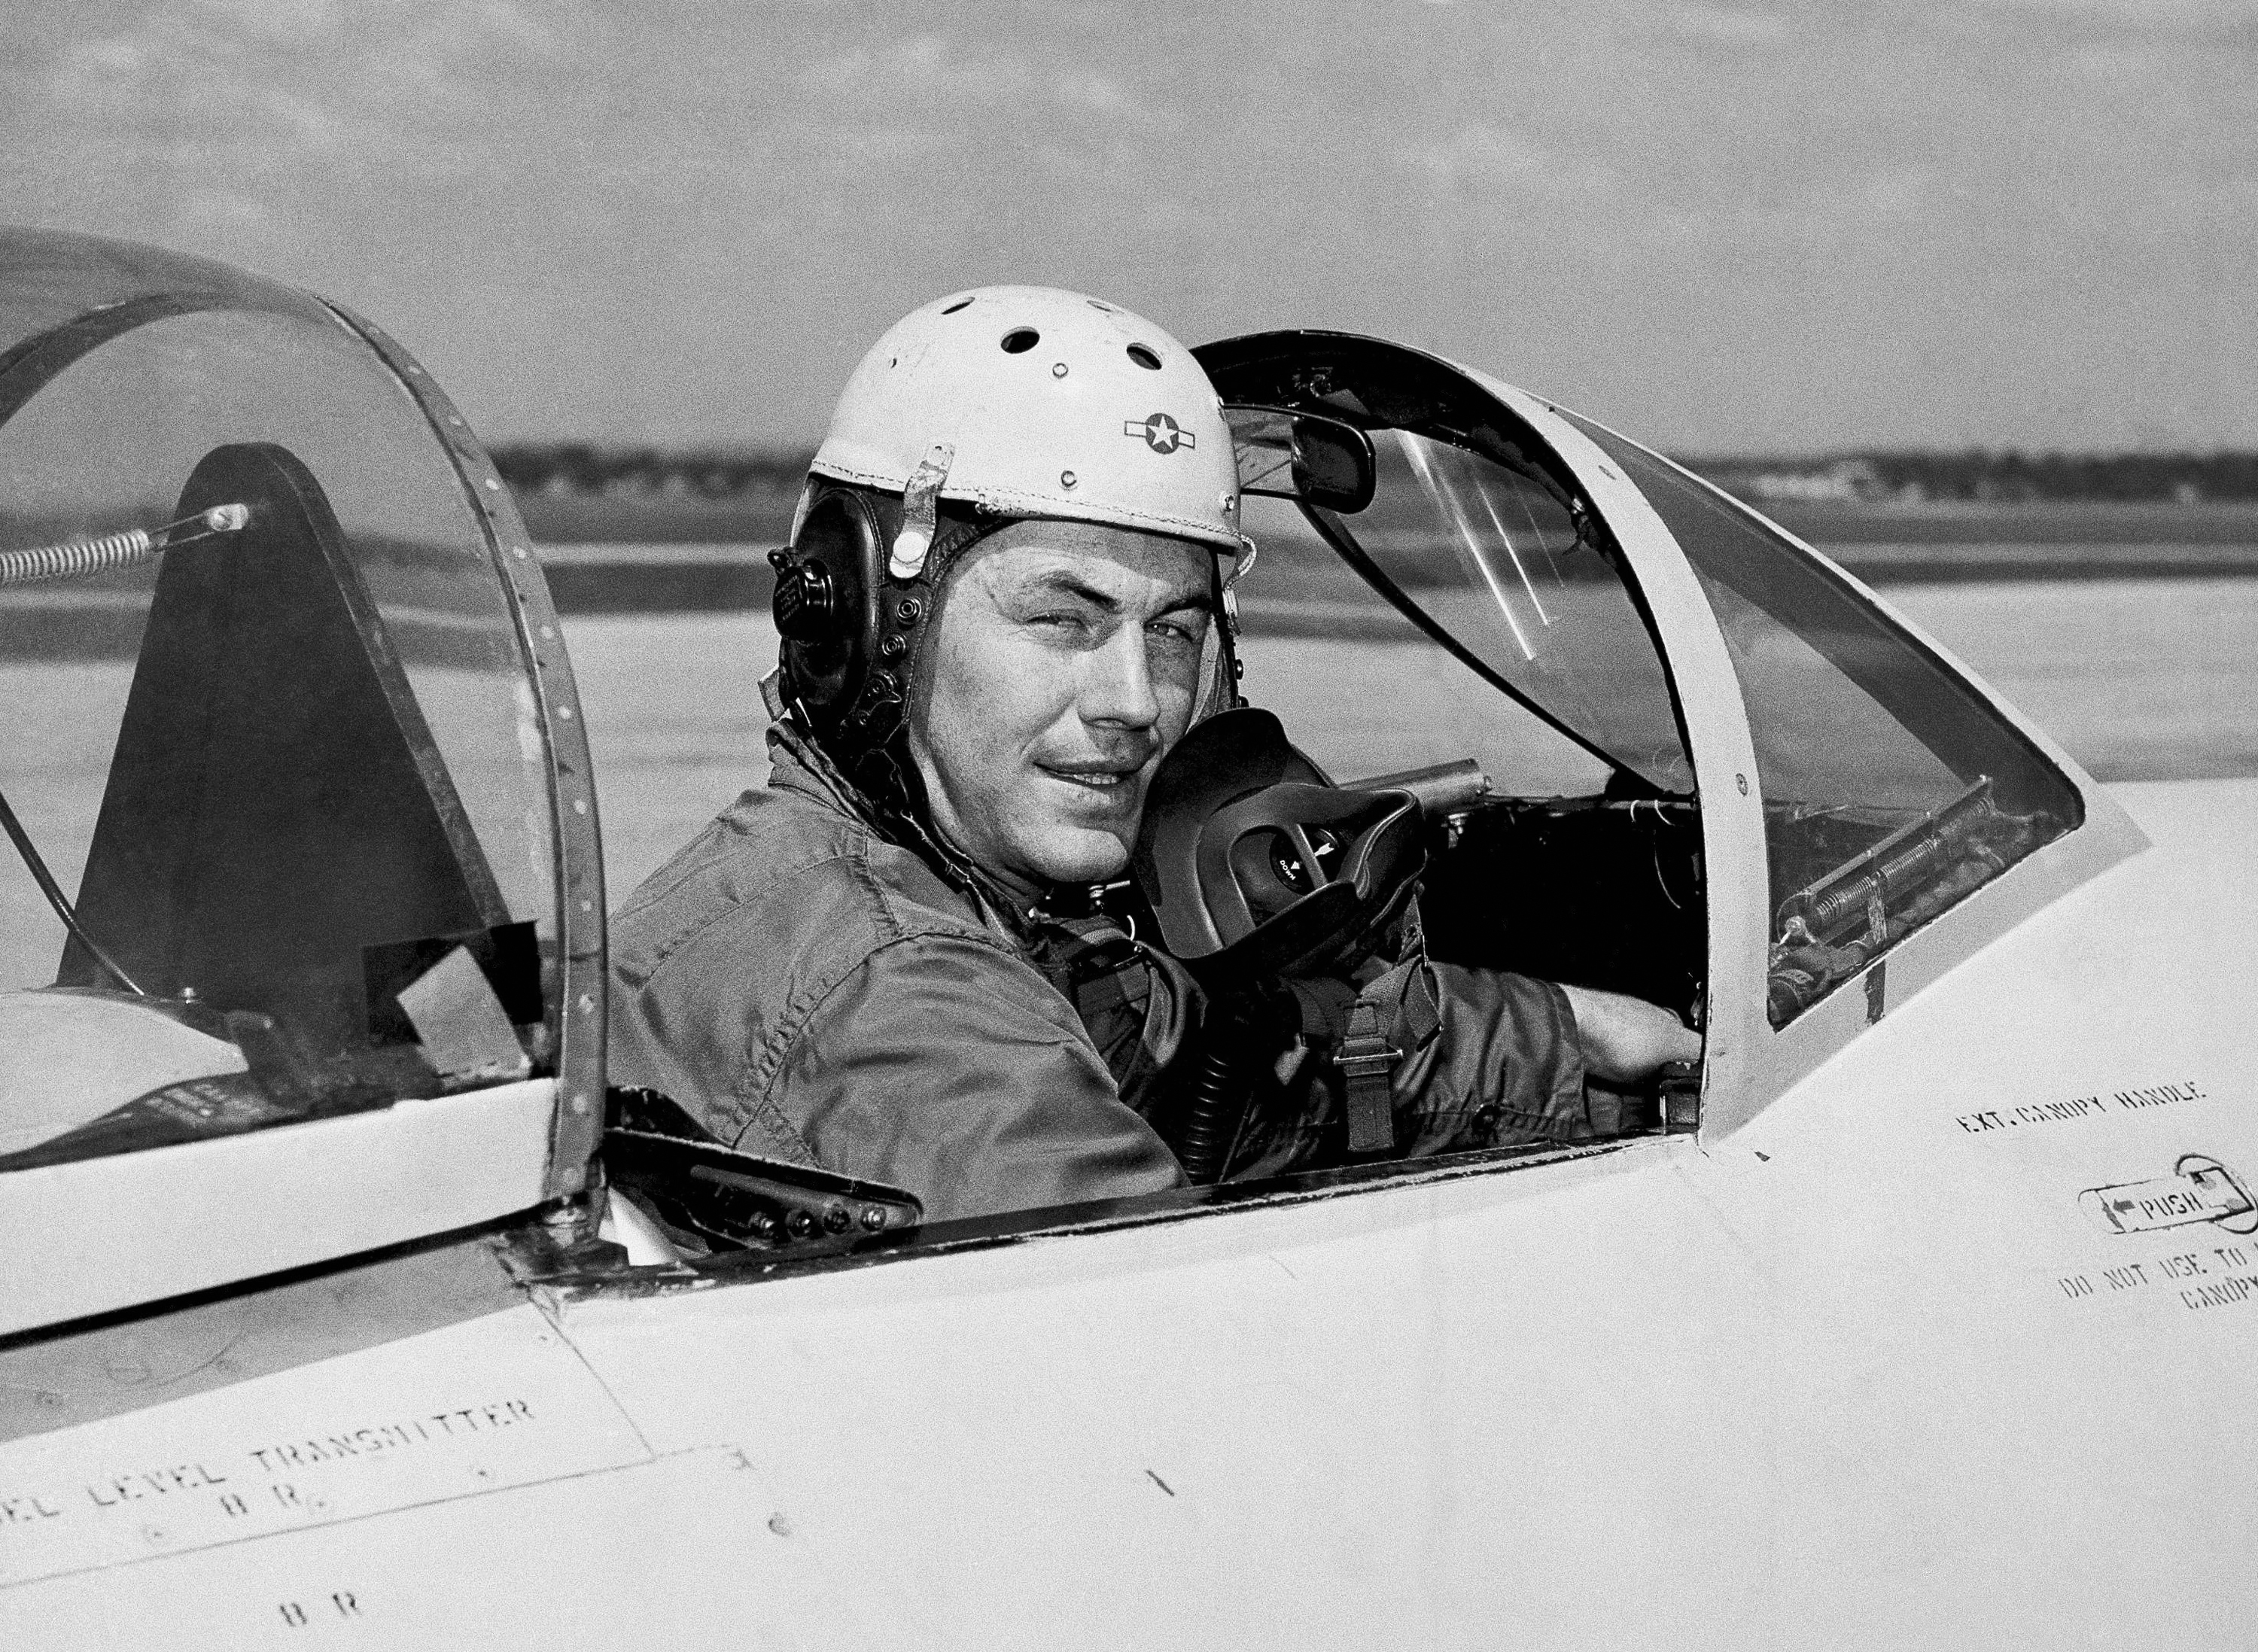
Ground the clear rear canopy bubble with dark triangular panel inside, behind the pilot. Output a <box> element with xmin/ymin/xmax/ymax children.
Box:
<box><xmin>0</xmin><ymin>230</ymin><xmax>592</xmax><ymax>1169</ymax></box>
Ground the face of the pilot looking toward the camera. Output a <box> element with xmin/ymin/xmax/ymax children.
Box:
<box><xmin>910</xmin><ymin>522</ymin><xmax>1215</xmax><ymax>898</ymax></box>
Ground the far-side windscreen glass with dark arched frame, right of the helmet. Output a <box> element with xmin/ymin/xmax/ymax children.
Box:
<box><xmin>1199</xmin><ymin>332</ymin><xmax>1694</xmax><ymax>799</ymax></box>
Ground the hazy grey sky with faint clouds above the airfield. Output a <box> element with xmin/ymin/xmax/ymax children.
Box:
<box><xmin>0</xmin><ymin>0</ymin><xmax>2258</xmax><ymax>454</ymax></box>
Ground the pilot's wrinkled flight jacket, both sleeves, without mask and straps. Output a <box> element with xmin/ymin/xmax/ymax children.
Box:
<box><xmin>610</xmin><ymin>723</ymin><xmax>1596</xmax><ymax>1221</ymax></box>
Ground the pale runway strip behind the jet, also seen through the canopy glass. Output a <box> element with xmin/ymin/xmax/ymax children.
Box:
<box><xmin>0</xmin><ymin>578</ymin><xmax>2258</xmax><ymax>986</ymax></box>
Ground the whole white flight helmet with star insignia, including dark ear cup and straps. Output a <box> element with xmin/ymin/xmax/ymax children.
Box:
<box><xmin>770</xmin><ymin>287</ymin><xmax>1249</xmax><ymax>756</ymax></box>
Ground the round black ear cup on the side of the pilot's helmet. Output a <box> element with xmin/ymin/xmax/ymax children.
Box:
<box><xmin>770</xmin><ymin>488</ymin><xmax>885</xmax><ymax>736</ymax></box>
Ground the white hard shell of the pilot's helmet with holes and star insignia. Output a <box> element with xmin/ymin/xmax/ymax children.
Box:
<box><xmin>815</xmin><ymin>287</ymin><xmax>1240</xmax><ymax>560</ymax></box>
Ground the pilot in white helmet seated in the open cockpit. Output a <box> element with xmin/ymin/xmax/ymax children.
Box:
<box><xmin>610</xmin><ymin>287</ymin><xmax>1700</xmax><ymax>1218</ymax></box>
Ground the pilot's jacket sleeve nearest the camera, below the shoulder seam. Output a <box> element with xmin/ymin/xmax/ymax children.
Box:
<box><xmin>763</xmin><ymin>934</ymin><xmax>1183</xmax><ymax>1221</ymax></box>
